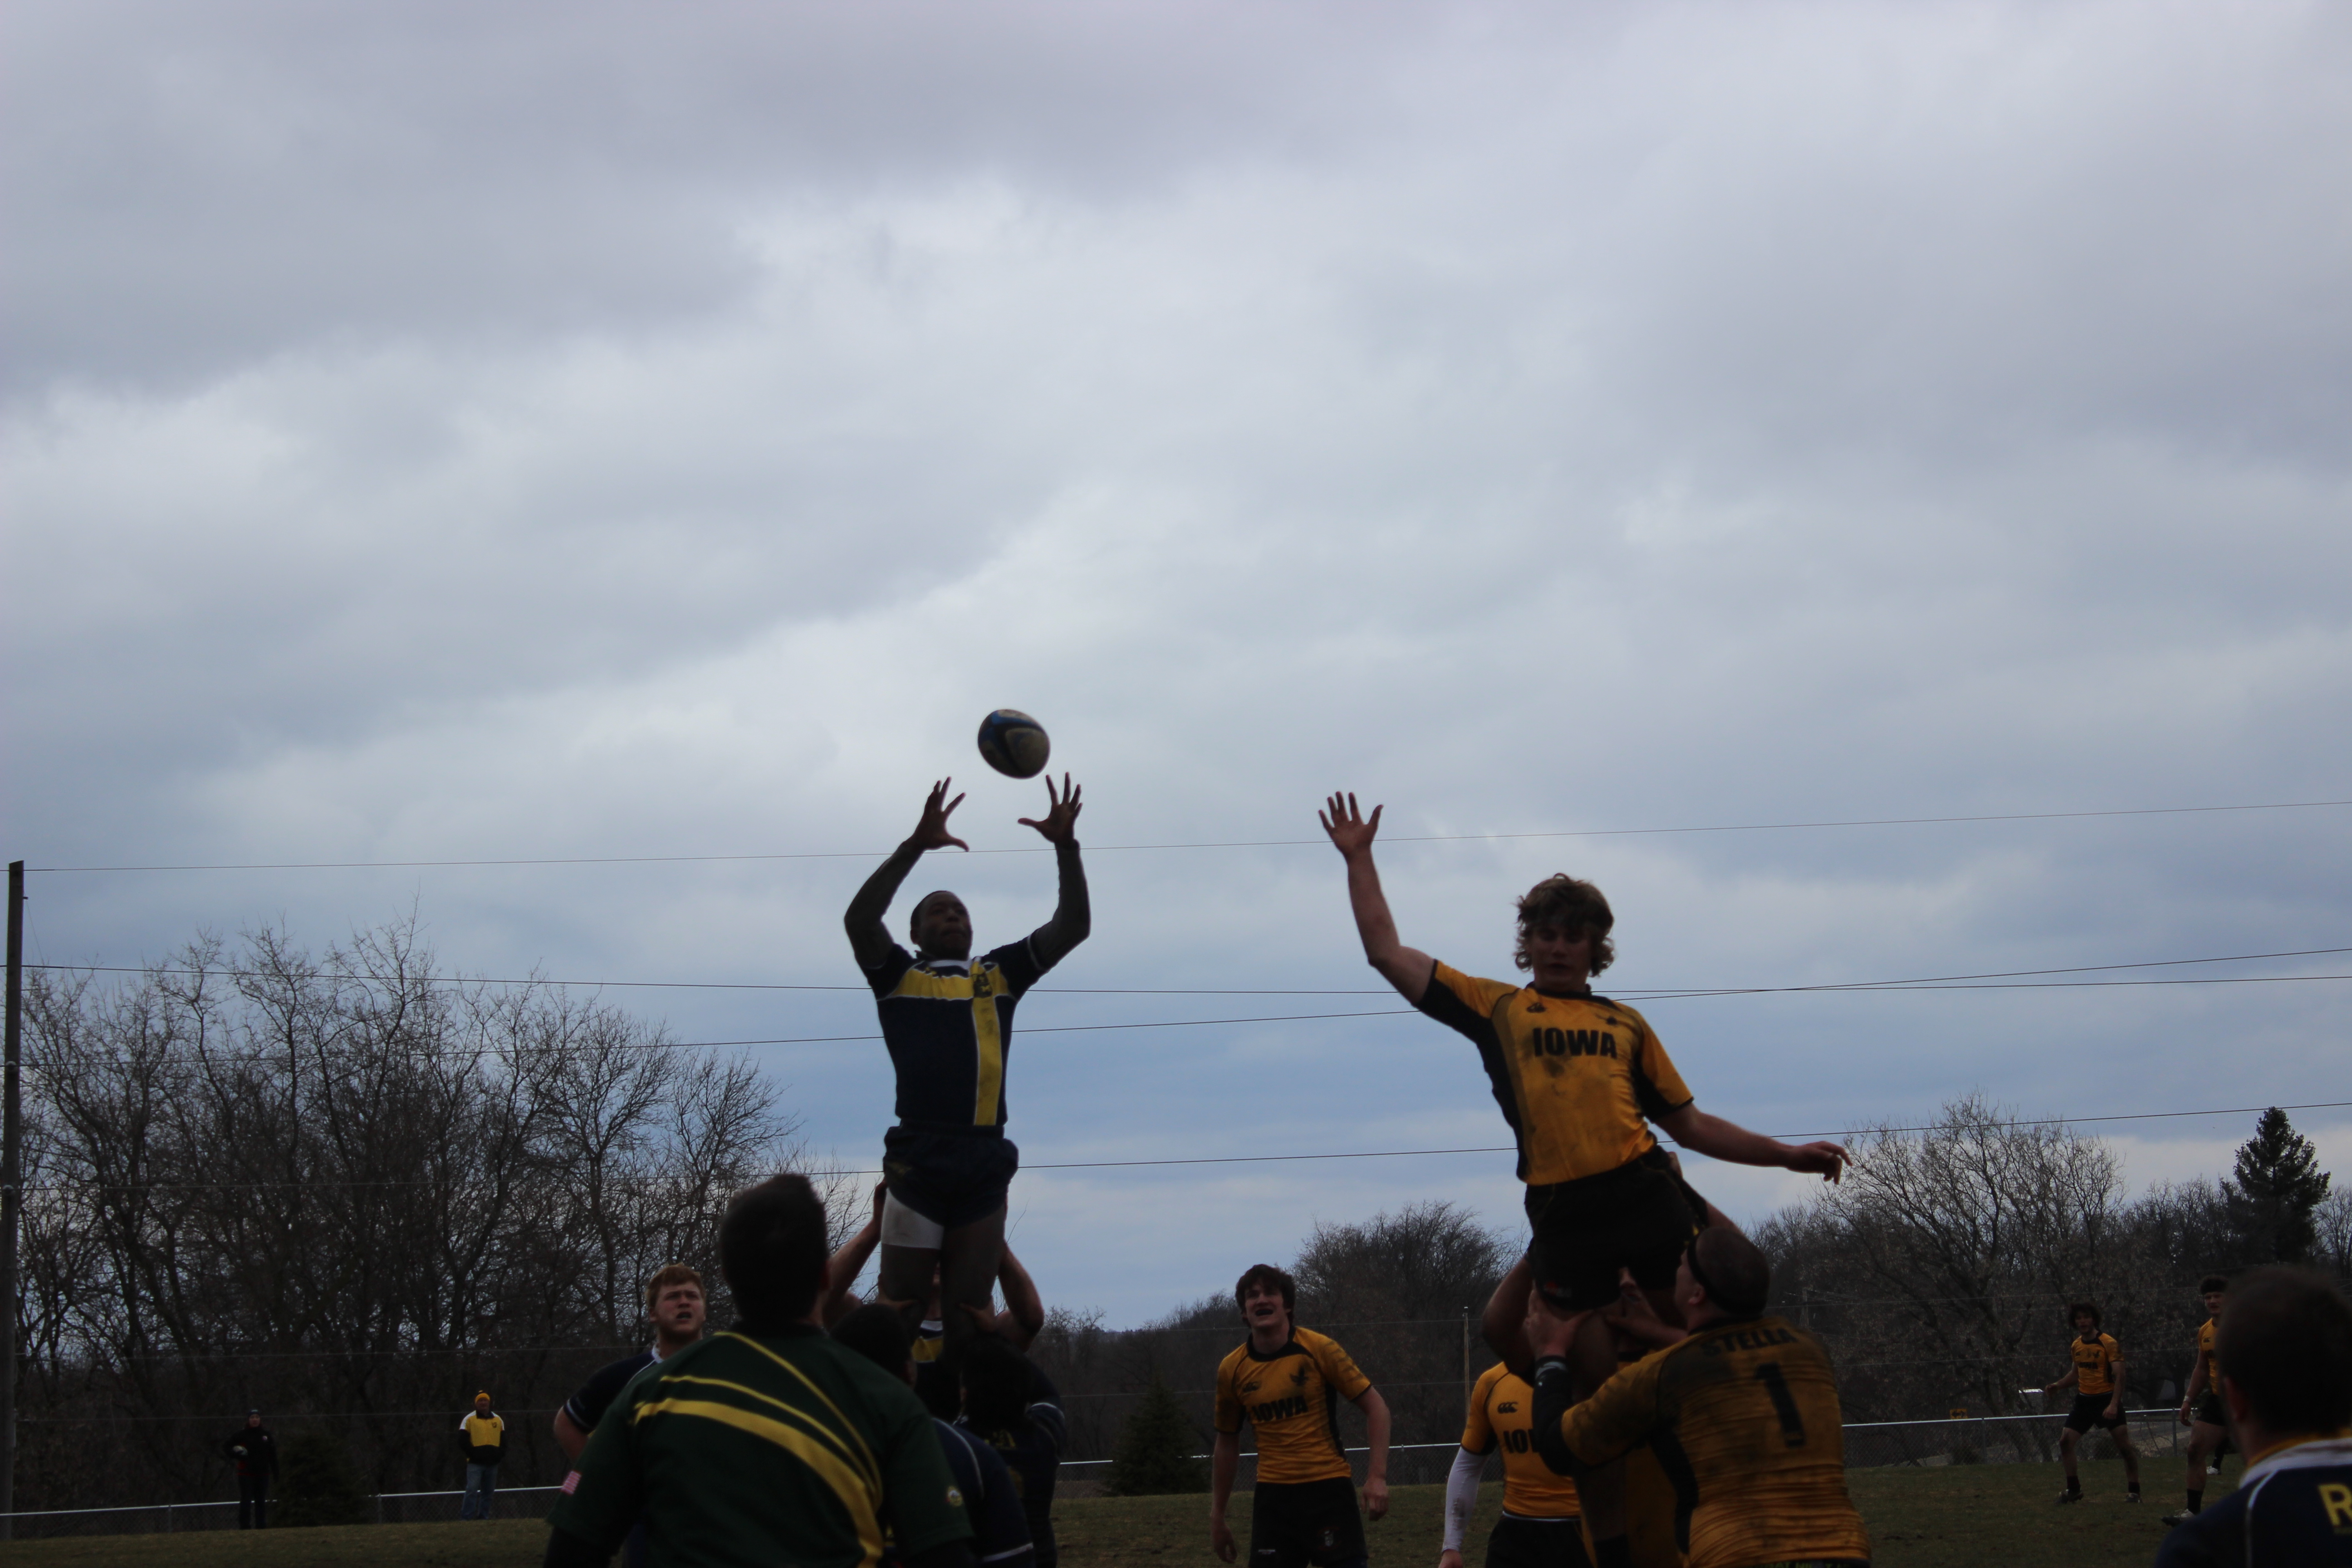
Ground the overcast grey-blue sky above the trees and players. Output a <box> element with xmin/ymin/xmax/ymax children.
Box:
<box><xmin>0</xmin><ymin>0</ymin><xmax>2352</xmax><ymax>1323</ymax></box>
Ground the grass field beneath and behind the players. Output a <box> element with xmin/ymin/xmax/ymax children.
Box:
<box><xmin>0</xmin><ymin>1465</ymin><xmax>2232</xmax><ymax>1568</ymax></box>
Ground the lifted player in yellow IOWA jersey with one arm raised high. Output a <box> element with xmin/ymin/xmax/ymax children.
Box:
<box><xmin>1322</xmin><ymin>794</ymin><xmax>1846</xmax><ymax>1568</ymax></box>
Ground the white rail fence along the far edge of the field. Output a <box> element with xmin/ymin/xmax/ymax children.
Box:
<box><xmin>0</xmin><ymin>1406</ymin><xmax>2187</xmax><ymax>1540</ymax></box>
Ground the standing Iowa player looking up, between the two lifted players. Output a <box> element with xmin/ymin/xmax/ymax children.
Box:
<box><xmin>1209</xmin><ymin>1262</ymin><xmax>1388</xmax><ymax>1568</ymax></box>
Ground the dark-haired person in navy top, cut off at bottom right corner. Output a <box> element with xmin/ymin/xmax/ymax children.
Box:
<box><xmin>2157</xmin><ymin>1269</ymin><xmax>2352</xmax><ymax>1568</ymax></box>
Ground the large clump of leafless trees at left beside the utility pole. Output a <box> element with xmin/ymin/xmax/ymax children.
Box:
<box><xmin>19</xmin><ymin>924</ymin><xmax>809</xmax><ymax>1507</ymax></box>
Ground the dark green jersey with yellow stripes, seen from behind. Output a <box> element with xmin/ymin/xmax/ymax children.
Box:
<box><xmin>548</xmin><ymin>1326</ymin><xmax>971</xmax><ymax>1568</ymax></box>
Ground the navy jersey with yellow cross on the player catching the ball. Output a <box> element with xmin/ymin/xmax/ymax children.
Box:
<box><xmin>866</xmin><ymin>938</ymin><xmax>1044</xmax><ymax>1133</ymax></box>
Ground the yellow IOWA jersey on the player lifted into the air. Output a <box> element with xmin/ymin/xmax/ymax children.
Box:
<box><xmin>1421</xmin><ymin>964</ymin><xmax>1691</xmax><ymax>1187</ymax></box>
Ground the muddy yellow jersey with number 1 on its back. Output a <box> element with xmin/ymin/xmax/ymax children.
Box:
<box><xmin>1559</xmin><ymin>1317</ymin><xmax>1870</xmax><ymax>1568</ymax></box>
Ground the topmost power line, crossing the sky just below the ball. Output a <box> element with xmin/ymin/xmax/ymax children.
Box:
<box><xmin>28</xmin><ymin>799</ymin><xmax>2352</xmax><ymax>874</ymax></box>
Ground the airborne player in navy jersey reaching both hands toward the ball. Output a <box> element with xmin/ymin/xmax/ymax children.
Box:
<box><xmin>842</xmin><ymin>776</ymin><xmax>1089</xmax><ymax>1357</ymax></box>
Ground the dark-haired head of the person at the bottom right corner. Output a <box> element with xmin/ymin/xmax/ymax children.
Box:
<box><xmin>2213</xmin><ymin>1267</ymin><xmax>2352</xmax><ymax>1436</ymax></box>
